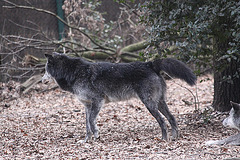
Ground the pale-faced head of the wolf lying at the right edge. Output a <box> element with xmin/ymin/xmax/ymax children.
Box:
<box><xmin>223</xmin><ymin>102</ymin><xmax>240</xmax><ymax>130</ymax></box>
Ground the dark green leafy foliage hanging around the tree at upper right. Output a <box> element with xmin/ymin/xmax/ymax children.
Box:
<box><xmin>141</xmin><ymin>0</ymin><xmax>240</xmax><ymax>74</ymax></box>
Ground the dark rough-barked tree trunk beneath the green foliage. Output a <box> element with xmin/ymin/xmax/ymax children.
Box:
<box><xmin>213</xmin><ymin>38</ymin><xmax>240</xmax><ymax>112</ymax></box>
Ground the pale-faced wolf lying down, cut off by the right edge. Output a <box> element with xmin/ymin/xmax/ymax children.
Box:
<box><xmin>206</xmin><ymin>102</ymin><xmax>240</xmax><ymax>146</ymax></box>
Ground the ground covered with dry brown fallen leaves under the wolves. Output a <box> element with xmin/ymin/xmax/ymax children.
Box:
<box><xmin>0</xmin><ymin>75</ymin><xmax>240</xmax><ymax>160</ymax></box>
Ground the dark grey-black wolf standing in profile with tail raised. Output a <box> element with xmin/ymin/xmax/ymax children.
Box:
<box><xmin>43</xmin><ymin>53</ymin><xmax>197</xmax><ymax>142</ymax></box>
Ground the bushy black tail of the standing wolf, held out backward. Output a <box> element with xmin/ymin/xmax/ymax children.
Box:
<box><xmin>152</xmin><ymin>58</ymin><xmax>197</xmax><ymax>86</ymax></box>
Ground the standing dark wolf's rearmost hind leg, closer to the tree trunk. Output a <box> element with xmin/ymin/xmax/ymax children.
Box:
<box><xmin>158</xmin><ymin>100</ymin><xmax>178</xmax><ymax>140</ymax></box>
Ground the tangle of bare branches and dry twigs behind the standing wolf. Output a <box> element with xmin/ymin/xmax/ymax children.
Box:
<box><xmin>0</xmin><ymin>0</ymin><xmax>150</xmax><ymax>79</ymax></box>
